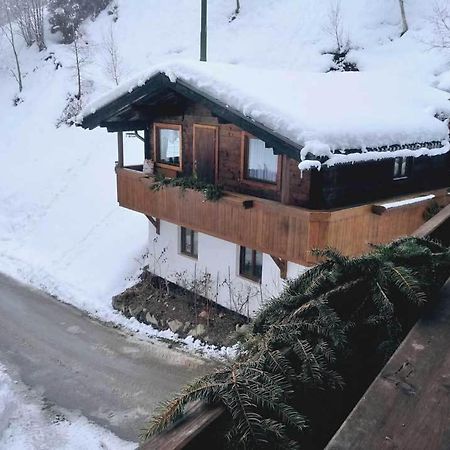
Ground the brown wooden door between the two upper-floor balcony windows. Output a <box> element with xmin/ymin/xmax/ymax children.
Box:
<box><xmin>194</xmin><ymin>125</ymin><xmax>218</xmax><ymax>184</ymax></box>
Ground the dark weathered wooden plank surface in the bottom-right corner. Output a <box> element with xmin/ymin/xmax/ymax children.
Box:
<box><xmin>326</xmin><ymin>280</ymin><xmax>450</xmax><ymax>450</ymax></box>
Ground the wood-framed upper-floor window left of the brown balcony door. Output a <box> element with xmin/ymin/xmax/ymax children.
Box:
<box><xmin>155</xmin><ymin>124</ymin><xmax>181</xmax><ymax>167</ymax></box>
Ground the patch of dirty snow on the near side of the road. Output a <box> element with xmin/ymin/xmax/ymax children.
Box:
<box><xmin>0</xmin><ymin>364</ymin><xmax>136</xmax><ymax>450</ymax></box>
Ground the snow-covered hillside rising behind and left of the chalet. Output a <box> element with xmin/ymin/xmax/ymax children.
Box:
<box><xmin>0</xmin><ymin>0</ymin><xmax>450</xmax><ymax>324</ymax></box>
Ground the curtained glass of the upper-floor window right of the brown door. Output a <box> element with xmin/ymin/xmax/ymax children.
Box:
<box><xmin>247</xmin><ymin>138</ymin><xmax>278</xmax><ymax>183</ymax></box>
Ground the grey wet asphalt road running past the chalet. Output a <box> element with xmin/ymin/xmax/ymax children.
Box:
<box><xmin>0</xmin><ymin>274</ymin><xmax>210</xmax><ymax>441</ymax></box>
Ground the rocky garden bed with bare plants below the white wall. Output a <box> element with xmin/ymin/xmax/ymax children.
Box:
<box><xmin>113</xmin><ymin>270</ymin><xmax>248</xmax><ymax>346</ymax></box>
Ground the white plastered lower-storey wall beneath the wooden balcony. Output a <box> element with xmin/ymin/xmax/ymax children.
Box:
<box><xmin>148</xmin><ymin>221</ymin><xmax>306</xmax><ymax>316</ymax></box>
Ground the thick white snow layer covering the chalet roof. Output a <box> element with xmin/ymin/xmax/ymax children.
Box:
<box><xmin>78</xmin><ymin>61</ymin><xmax>450</xmax><ymax>163</ymax></box>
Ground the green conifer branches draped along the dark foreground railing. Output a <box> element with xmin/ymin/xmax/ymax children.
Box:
<box><xmin>144</xmin><ymin>238</ymin><xmax>450</xmax><ymax>450</ymax></box>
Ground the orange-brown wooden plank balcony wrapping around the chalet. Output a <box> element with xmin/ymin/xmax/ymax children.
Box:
<box><xmin>116</xmin><ymin>168</ymin><xmax>450</xmax><ymax>266</ymax></box>
